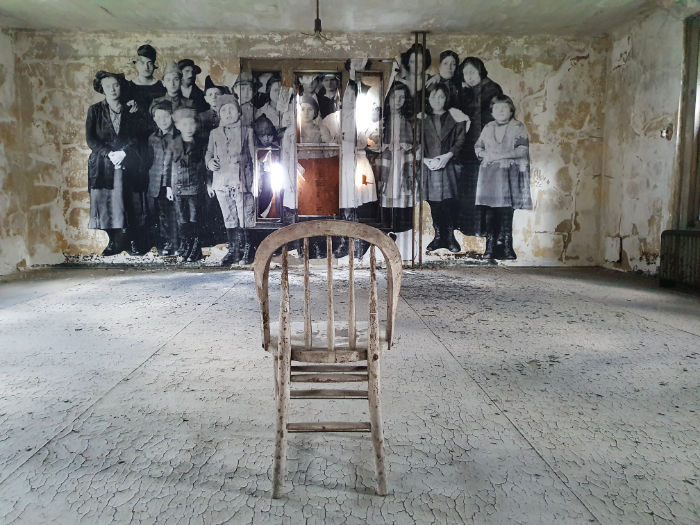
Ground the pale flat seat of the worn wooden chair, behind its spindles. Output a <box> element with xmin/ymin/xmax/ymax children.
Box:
<box><xmin>268</xmin><ymin>321</ymin><xmax>387</xmax><ymax>363</ymax></box>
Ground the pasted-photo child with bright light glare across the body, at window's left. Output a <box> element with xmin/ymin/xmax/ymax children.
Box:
<box><xmin>253</xmin><ymin>115</ymin><xmax>284</xmax><ymax>219</ymax></box>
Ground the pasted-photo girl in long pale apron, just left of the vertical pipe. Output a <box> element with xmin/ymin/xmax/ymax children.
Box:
<box><xmin>377</xmin><ymin>83</ymin><xmax>413</xmax><ymax>233</ymax></box>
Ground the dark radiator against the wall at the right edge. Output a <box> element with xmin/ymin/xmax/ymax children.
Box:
<box><xmin>659</xmin><ymin>230</ymin><xmax>700</xmax><ymax>288</ymax></box>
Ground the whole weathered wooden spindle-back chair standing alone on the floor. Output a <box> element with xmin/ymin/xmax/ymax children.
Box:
<box><xmin>253</xmin><ymin>220</ymin><xmax>401</xmax><ymax>498</ymax></box>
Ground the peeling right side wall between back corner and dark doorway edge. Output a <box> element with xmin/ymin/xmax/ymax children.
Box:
<box><xmin>601</xmin><ymin>10</ymin><xmax>684</xmax><ymax>273</ymax></box>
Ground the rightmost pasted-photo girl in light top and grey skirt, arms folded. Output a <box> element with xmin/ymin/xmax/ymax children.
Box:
<box><xmin>475</xmin><ymin>95</ymin><xmax>532</xmax><ymax>260</ymax></box>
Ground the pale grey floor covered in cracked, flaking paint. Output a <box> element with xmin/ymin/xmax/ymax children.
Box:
<box><xmin>0</xmin><ymin>268</ymin><xmax>700</xmax><ymax>524</ymax></box>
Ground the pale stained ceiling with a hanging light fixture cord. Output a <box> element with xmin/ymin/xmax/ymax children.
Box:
<box><xmin>0</xmin><ymin>0</ymin><xmax>659</xmax><ymax>35</ymax></box>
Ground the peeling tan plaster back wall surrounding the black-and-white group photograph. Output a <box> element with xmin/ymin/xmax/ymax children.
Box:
<box><xmin>0</xmin><ymin>31</ymin><xmax>609</xmax><ymax>272</ymax></box>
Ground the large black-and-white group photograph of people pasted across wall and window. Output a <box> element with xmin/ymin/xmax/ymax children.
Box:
<box><xmin>86</xmin><ymin>44</ymin><xmax>532</xmax><ymax>266</ymax></box>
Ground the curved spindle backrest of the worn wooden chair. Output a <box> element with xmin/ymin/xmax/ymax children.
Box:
<box><xmin>253</xmin><ymin>220</ymin><xmax>402</xmax><ymax>350</ymax></box>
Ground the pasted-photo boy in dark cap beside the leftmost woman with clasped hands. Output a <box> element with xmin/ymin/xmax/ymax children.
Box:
<box><xmin>146</xmin><ymin>100</ymin><xmax>181</xmax><ymax>255</ymax></box>
